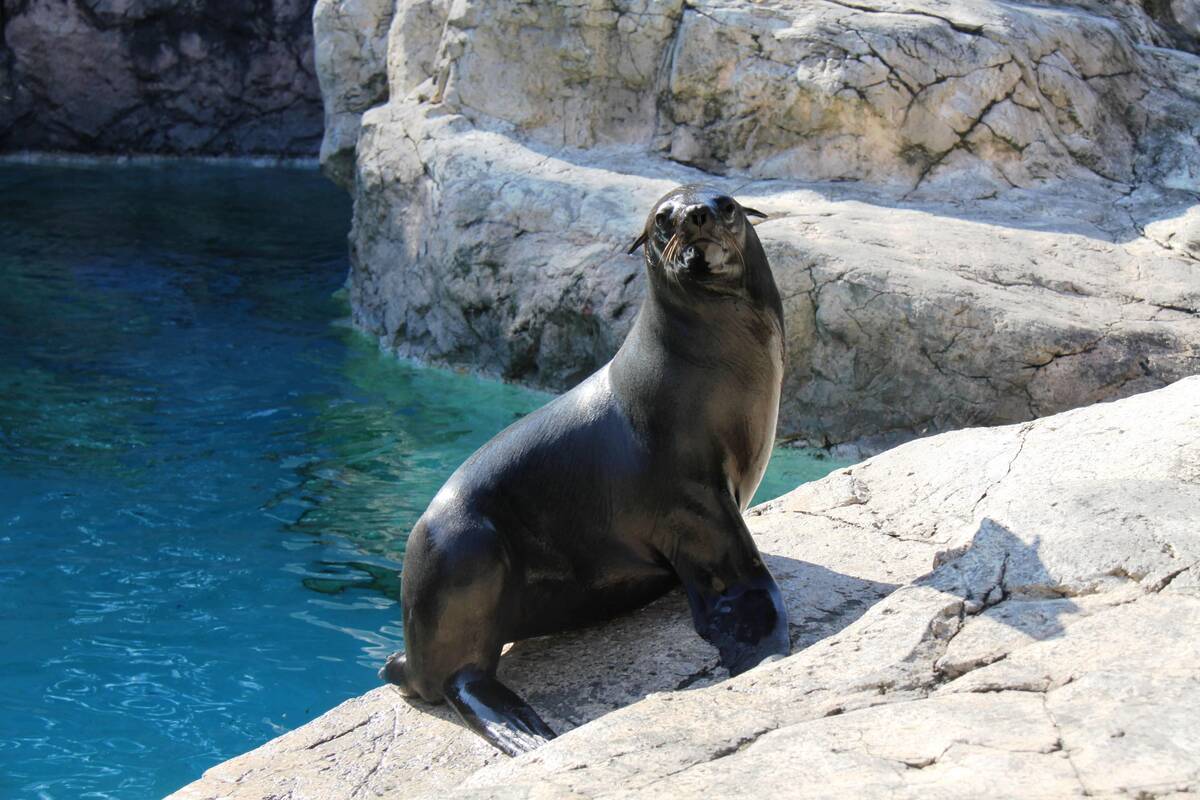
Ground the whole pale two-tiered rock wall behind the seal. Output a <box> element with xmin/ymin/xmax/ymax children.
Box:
<box><xmin>318</xmin><ymin>0</ymin><xmax>1200</xmax><ymax>444</ymax></box>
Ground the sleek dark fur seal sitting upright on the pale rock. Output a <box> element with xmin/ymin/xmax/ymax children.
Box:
<box><xmin>379</xmin><ymin>186</ymin><xmax>791</xmax><ymax>756</ymax></box>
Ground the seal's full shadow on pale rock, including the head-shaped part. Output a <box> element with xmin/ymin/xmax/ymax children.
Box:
<box><xmin>393</xmin><ymin>518</ymin><xmax>1078</xmax><ymax>733</ymax></box>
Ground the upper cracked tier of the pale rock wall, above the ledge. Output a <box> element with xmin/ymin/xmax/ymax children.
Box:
<box><xmin>372</xmin><ymin>0</ymin><xmax>1194</xmax><ymax>188</ymax></box>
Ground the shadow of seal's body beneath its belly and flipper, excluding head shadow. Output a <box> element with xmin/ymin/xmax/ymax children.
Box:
<box><xmin>398</xmin><ymin>554</ymin><xmax>895</xmax><ymax>733</ymax></box>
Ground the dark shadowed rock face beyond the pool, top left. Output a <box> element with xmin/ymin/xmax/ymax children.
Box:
<box><xmin>0</xmin><ymin>0</ymin><xmax>322</xmax><ymax>156</ymax></box>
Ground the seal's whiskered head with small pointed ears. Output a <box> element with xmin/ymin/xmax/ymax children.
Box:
<box><xmin>629</xmin><ymin>184</ymin><xmax>767</xmax><ymax>294</ymax></box>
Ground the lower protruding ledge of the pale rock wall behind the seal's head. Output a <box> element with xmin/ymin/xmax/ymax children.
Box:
<box><xmin>350</xmin><ymin>104</ymin><xmax>1200</xmax><ymax>444</ymax></box>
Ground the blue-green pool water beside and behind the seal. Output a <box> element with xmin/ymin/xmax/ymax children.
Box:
<box><xmin>0</xmin><ymin>164</ymin><xmax>836</xmax><ymax>798</ymax></box>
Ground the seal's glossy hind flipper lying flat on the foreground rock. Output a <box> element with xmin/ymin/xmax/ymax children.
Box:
<box><xmin>445</xmin><ymin>667</ymin><xmax>556</xmax><ymax>756</ymax></box>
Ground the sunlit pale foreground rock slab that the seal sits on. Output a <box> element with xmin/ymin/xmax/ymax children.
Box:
<box><xmin>172</xmin><ymin>378</ymin><xmax>1200</xmax><ymax>800</ymax></box>
